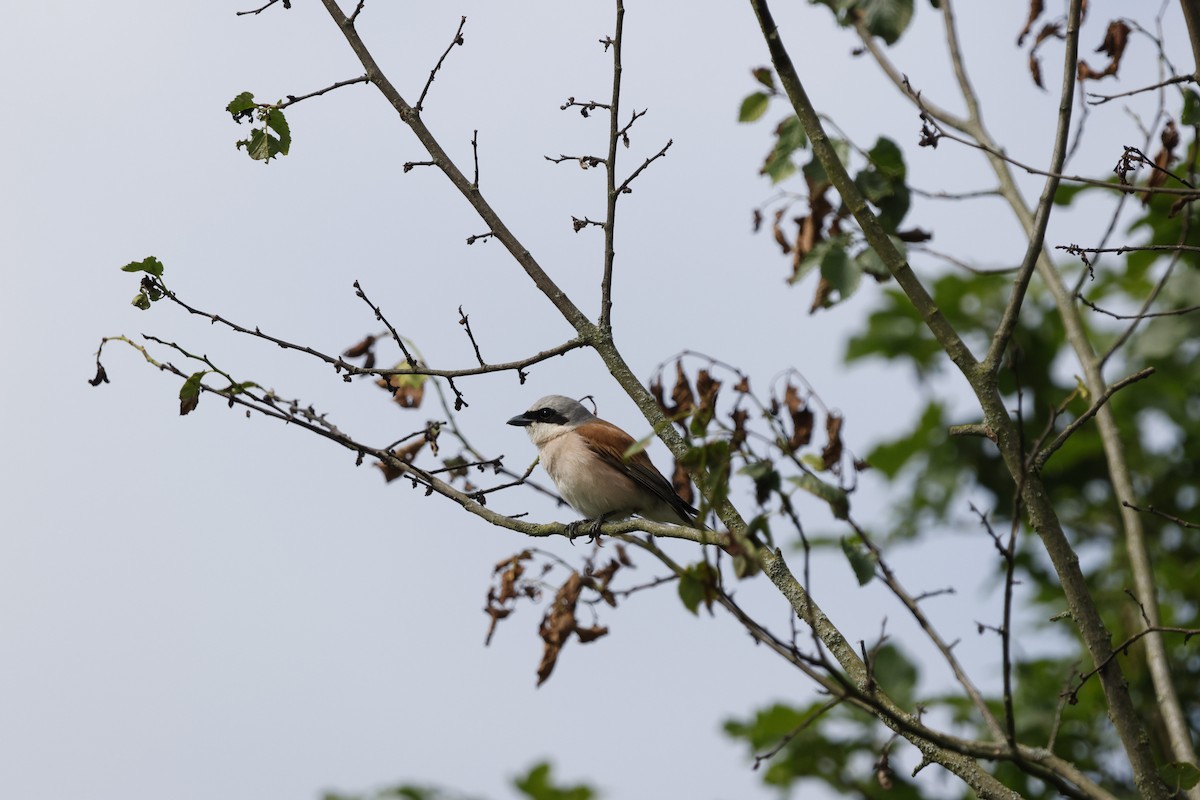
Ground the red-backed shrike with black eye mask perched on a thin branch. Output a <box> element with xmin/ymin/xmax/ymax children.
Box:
<box><xmin>509</xmin><ymin>395</ymin><xmax>697</xmax><ymax>531</ymax></box>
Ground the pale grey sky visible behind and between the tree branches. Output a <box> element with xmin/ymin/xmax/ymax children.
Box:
<box><xmin>0</xmin><ymin>0</ymin><xmax>1187</xmax><ymax>800</ymax></box>
